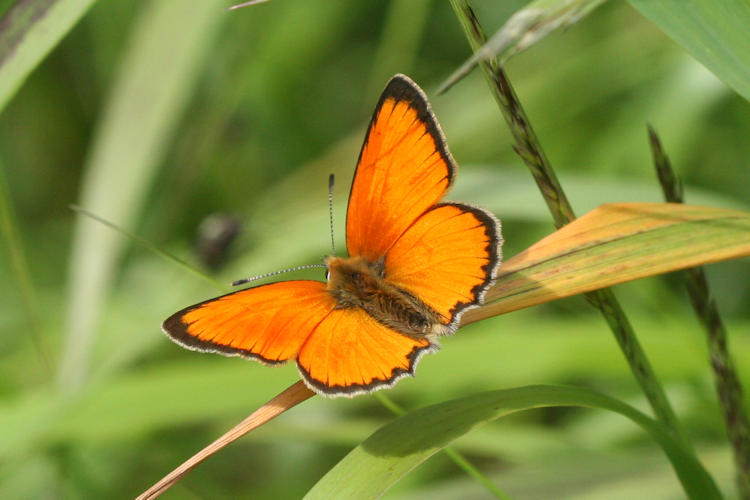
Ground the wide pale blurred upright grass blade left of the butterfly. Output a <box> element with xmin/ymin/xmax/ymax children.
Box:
<box><xmin>59</xmin><ymin>0</ymin><xmax>225</xmax><ymax>390</ymax></box>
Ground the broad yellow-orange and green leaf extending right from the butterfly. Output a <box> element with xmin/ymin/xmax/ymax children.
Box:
<box><xmin>463</xmin><ymin>203</ymin><xmax>750</xmax><ymax>324</ymax></box>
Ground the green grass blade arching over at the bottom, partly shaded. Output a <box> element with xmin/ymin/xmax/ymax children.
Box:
<box><xmin>305</xmin><ymin>386</ymin><xmax>721</xmax><ymax>499</ymax></box>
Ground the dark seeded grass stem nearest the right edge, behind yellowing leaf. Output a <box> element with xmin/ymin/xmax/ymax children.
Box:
<box><xmin>648</xmin><ymin>126</ymin><xmax>750</xmax><ymax>499</ymax></box>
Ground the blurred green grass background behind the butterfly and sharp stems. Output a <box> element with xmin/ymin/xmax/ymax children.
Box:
<box><xmin>0</xmin><ymin>0</ymin><xmax>750</xmax><ymax>499</ymax></box>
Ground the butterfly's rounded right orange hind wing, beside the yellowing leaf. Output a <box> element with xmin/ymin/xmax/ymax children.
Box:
<box><xmin>385</xmin><ymin>203</ymin><xmax>502</xmax><ymax>330</ymax></box>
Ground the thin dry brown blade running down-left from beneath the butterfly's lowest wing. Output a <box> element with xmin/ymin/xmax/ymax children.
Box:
<box><xmin>138</xmin><ymin>380</ymin><xmax>315</xmax><ymax>500</ymax></box>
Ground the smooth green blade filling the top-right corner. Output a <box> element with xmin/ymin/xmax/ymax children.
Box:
<box><xmin>630</xmin><ymin>0</ymin><xmax>750</xmax><ymax>100</ymax></box>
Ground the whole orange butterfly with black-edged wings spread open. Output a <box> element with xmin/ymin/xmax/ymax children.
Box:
<box><xmin>162</xmin><ymin>74</ymin><xmax>503</xmax><ymax>397</ymax></box>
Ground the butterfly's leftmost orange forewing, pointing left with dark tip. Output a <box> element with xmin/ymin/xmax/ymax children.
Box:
<box><xmin>167</xmin><ymin>280</ymin><xmax>336</xmax><ymax>364</ymax></box>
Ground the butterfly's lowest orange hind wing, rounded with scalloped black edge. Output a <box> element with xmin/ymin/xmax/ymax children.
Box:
<box><xmin>297</xmin><ymin>308</ymin><xmax>437</xmax><ymax>396</ymax></box>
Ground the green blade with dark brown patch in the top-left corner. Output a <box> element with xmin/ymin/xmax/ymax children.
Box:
<box><xmin>0</xmin><ymin>0</ymin><xmax>100</xmax><ymax>110</ymax></box>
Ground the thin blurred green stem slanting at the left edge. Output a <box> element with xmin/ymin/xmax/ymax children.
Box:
<box><xmin>0</xmin><ymin>162</ymin><xmax>52</xmax><ymax>377</ymax></box>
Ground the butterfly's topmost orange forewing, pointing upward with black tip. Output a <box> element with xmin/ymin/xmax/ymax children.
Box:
<box><xmin>346</xmin><ymin>75</ymin><xmax>456</xmax><ymax>262</ymax></box>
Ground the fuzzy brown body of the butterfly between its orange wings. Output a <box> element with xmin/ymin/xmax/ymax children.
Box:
<box><xmin>326</xmin><ymin>257</ymin><xmax>446</xmax><ymax>337</ymax></box>
